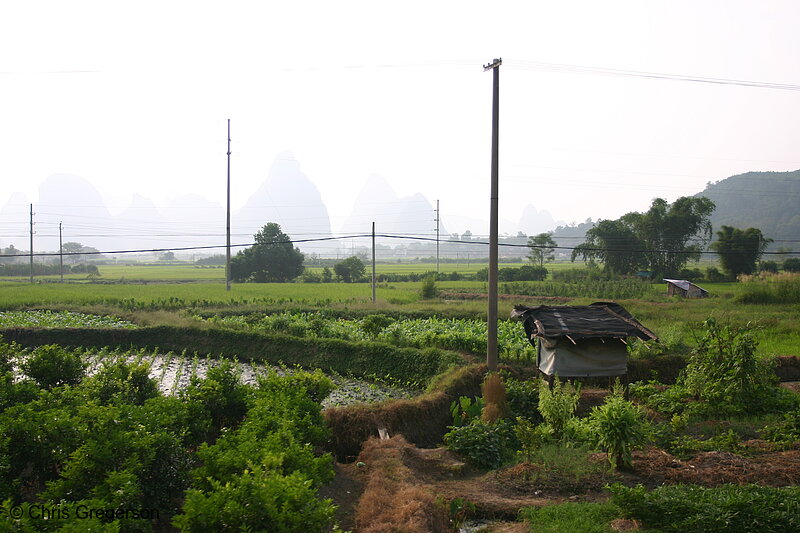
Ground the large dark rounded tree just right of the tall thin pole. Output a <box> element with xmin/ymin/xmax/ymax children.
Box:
<box><xmin>231</xmin><ymin>222</ymin><xmax>305</xmax><ymax>283</ymax></box>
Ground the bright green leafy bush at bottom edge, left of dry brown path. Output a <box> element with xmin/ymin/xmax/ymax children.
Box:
<box><xmin>173</xmin><ymin>465</ymin><xmax>334</xmax><ymax>533</ymax></box>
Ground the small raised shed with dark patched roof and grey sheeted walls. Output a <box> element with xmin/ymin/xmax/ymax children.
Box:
<box><xmin>511</xmin><ymin>302</ymin><xmax>657</xmax><ymax>378</ymax></box>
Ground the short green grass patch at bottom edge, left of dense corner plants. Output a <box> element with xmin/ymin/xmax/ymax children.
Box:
<box><xmin>520</xmin><ymin>502</ymin><xmax>619</xmax><ymax>533</ymax></box>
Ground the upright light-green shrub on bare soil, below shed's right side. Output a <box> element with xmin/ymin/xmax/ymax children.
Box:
<box><xmin>589</xmin><ymin>390</ymin><xmax>650</xmax><ymax>469</ymax></box>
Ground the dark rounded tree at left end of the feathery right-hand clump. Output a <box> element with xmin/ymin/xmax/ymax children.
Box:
<box><xmin>572</xmin><ymin>220</ymin><xmax>647</xmax><ymax>274</ymax></box>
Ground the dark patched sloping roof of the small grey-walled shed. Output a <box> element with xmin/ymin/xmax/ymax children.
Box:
<box><xmin>511</xmin><ymin>302</ymin><xmax>657</xmax><ymax>341</ymax></box>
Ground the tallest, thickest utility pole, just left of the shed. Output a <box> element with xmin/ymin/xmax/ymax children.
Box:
<box><xmin>483</xmin><ymin>59</ymin><xmax>503</xmax><ymax>372</ymax></box>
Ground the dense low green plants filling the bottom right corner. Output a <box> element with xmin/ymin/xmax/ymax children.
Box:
<box><xmin>610</xmin><ymin>483</ymin><xmax>800</xmax><ymax>533</ymax></box>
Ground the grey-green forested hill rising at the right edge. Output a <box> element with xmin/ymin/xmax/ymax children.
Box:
<box><xmin>695</xmin><ymin>170</ymin><xmax>800</xmax><ymax>240</ymax></box>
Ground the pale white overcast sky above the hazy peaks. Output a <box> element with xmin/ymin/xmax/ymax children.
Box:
<box><xmin>0</xmin><ymin>0</ymin><xmax>800</xmax><ymax>245</ymax></box>
